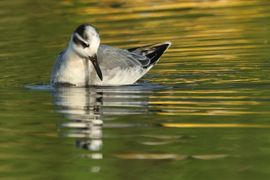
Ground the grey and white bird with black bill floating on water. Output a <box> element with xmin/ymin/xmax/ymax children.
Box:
<box><xmin>51</xmin><ymin>23</ymin><xmax>171</xmax><ymax>87</ymax></box>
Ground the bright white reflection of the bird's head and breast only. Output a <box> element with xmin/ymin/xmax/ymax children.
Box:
<box><xmin>54</xmin><ymin>87</ymin><xmax>103</xmax><ymax>151</ymax></box>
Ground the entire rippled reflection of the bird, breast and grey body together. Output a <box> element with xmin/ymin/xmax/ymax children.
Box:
<box><xmin>53</xmin><ymin>86</ymin><xmax>152</xmax><ymax>152</ymax></box>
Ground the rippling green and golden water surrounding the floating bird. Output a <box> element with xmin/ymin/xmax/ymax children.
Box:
<box><xmin>0</xmin><ymin>0</ymin><xmax>270</xmax><ymax>180</ymax></box>
